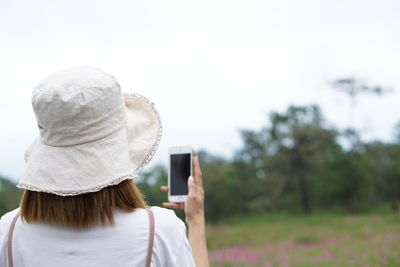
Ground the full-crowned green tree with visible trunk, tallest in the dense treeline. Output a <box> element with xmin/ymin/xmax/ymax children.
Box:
<box><xmin>269</xmin><ymin>105</ymin><xmax>339</xmax><ymax>213</ymax></box>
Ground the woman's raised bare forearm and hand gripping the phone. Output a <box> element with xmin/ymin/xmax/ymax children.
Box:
<box><xmin>161</xmin><ymin>156</ymin><xmax>209</xmax><ymax>267</ymax></box>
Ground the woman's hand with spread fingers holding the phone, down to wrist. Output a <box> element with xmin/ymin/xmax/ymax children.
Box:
<box><xmin>161</xmin><ymin>156</ymin><xmax>204</xmax><ymax>224</ymax></box>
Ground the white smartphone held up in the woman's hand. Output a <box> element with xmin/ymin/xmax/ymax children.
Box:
<box><xmin>168</xmin><ymin>146</ymin><xmax>194</xmax><ymax>202</ymax></box>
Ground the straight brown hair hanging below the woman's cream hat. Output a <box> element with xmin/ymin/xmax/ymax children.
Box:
<box><xmin>20</xmin><ymin>180</ymin><xmax>146</xmax><ymax>228</ymax></box>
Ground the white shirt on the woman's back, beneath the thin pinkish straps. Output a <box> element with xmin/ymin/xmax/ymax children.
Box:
<box><xmin>0</xmin><ymin>207</ymin><xmax>195</xmax><ymax>267</ymax></box>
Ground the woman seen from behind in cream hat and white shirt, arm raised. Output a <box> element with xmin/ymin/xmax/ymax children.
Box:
<box><xmin>0</xmin><ymin>67</ymin><xmax>208</xmax><ymax>267</ymax></box>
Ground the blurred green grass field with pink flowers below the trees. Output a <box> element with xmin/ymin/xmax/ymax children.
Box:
<box><xmin>207</xmin><ymin>211</ymin><xmax>400</xmax><ymax>267</ymax></box>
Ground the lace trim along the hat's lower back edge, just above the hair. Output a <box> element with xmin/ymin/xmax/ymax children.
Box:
<box><xmin>17</xmin><ymin>174</ymin><xmax>138</xmax><ymax>197</ymax></box>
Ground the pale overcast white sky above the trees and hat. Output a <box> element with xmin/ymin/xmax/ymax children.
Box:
<box><xmin>0</xmin><ymin>0</ymin><xmax>400</xmax><ymax>181</ymax></box>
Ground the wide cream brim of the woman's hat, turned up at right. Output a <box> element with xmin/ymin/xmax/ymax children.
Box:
<box><xmin>18</xmin><ymin>94</ymin><xmax>162</xmax><ymax>196</ymax></box>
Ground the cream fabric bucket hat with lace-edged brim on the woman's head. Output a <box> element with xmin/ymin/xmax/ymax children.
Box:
<box><xmin>18</xmin><ymin>67</ymin><xmax>162</xmax><ymax>196</ymax></box>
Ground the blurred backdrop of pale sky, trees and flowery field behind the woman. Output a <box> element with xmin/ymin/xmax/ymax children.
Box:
<box><xmin>0</xmin><ymin>0</ymin><xmax>400</xmax><ymax>266</ymax></box>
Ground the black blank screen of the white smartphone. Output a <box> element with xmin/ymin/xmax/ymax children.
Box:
<box><xmin>169</xmin><ymin>153</ymin><xmax>191</xmax><ymax>196</ymax></box>
